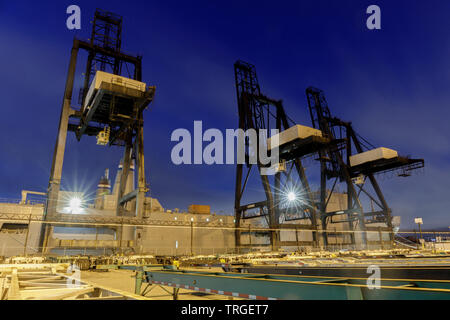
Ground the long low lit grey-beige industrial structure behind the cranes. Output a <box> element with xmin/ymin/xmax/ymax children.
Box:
<box><xmin>0</xmin><ymin>160</ymin><xmax>370</xmax><ymax>257</ymax></box>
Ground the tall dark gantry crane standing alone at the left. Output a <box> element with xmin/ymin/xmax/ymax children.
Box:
<box><xmin>41</xmin><ymin>10</ymin><xmax>155</xmax><ymax>252</ymax></box>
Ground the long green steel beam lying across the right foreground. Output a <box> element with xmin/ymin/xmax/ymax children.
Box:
<box><xmin>98</xmin><ymin>265</ymin><xmax>450</xmax><ymax>300</ymax></box>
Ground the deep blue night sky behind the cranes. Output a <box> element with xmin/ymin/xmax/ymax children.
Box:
<box><xmin>0</xmin><ymin>0</ymin><xmax>450</xmax><ymax>228</ymax></box>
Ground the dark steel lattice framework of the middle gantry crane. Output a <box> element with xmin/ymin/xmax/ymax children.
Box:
<box><xmin>234</xmin><ymin>61</ymin><xmax>317</xmax><ymax>249</ymax></box>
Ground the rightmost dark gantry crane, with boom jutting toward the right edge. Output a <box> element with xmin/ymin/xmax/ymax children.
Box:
<box><xmin>306</xmin><ymin>87</ymin><xmax>424</xmax><ymax>246</ymax></box>
